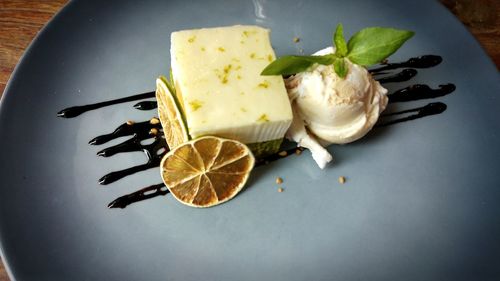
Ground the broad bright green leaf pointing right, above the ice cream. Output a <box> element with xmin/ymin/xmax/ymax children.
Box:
<box><xmin>347</xmin><ymin>27</ymin><xmax>415</xmax><ymax>66</ymax></box>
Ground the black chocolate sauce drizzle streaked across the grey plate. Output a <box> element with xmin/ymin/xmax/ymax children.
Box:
<box><xmin>57</xmin><ymin>55</ymin><xmax>455</xmax><ymax>208</ymax></box>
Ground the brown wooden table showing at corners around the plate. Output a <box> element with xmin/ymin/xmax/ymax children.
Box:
<box><xmin>0</xmin><ymin>0</ymin><xmax>500</xmax><ymax>281</ymax></box>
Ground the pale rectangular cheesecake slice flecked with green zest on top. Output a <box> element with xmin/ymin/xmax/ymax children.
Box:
<box><xmin>170</xmin><ymin>25</ymin><xmax>292</xmax><ymax>156</ymax></box>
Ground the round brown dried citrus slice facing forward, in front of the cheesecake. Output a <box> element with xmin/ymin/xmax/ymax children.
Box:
<box><xmin>161</xmin><ymin>137</ymin><xmax>255</xmax><ymax>207</ymax></box>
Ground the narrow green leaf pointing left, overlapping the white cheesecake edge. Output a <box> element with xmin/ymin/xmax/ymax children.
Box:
<box><xmin>260</xmin><ymin>55</ymin><xmax>335</xmax><ymax>75</ymax></box>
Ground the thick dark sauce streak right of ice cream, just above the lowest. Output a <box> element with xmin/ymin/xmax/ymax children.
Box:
<box><xmin>388</xmin><ymin>84</ymin><xmax>456</xmax><ymax>103</ymax></box>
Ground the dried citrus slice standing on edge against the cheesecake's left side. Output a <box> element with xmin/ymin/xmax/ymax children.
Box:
<box><xmin>156</xmin><ymin>74</ymin><xmax>189</xmax><ymax>149</ymax></box>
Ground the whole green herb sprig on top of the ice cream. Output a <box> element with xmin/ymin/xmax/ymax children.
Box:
<box><xmin>261</xmin><ymin>24</ymin><xmax>415</xmax><ymax>78</ymax></box>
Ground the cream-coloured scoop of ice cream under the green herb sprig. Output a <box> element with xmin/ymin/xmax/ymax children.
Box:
<box><xmin>285</xmin><ymin>47</ymin><xmax>388</xmax><ymax>144</ymax></box>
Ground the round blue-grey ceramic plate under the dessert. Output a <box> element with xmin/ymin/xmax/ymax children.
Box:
<box><xmin>0</xmin><ymin>0</ymin><xmax>500</xmax><ymax>280</ymax></box>
